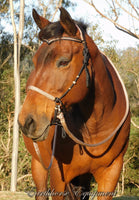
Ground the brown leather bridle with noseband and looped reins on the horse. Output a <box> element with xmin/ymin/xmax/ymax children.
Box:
<box><xmin>28</xmin><ymin>25</ymin><xmax>129</xmax><ymax>170</ymax></box>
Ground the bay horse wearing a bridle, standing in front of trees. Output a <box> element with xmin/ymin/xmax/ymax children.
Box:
<box><xmin>18</xmin><ymin>7</ymin><xmax>130</xmax><ymax>200</ymax></box>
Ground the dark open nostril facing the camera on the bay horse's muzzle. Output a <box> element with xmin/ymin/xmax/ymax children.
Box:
<box><xmin>23</xmin><ymin>115</ymin><xmax>36</xmax><ymax>134</ymax></box>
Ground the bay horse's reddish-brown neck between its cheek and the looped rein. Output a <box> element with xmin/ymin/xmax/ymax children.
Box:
<box><xmin>80</xmin><ymin>38</ymin><xmax>115</xmax><ymax>132</ymax></box>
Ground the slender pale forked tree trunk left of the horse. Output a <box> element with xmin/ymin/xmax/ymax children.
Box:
<box><xmin>9</xmin><ymin>0</ymin><xmax>24</xmax><ymax>192</ymax></box>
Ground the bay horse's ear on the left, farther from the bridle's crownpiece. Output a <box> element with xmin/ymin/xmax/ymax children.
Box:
<box><xmin>32</xmin><ymin>9</ymin><xmax>50</xmax><ymax>29</ymax></box>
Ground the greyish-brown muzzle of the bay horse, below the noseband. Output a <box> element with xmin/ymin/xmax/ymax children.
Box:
<box><xmin>18</xmin><ymin>115</ymin><xmax>50</xmax><ymax>141</ymax></box>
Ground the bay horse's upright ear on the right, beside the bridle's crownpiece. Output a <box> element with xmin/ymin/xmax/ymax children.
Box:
<box><xmin>59</xmin><ymin>7</ymin><xmax>77</xmax><ymax>35</ymax></box>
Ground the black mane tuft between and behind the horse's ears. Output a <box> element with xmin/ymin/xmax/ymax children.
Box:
<box><xmin>39</xmin><ymin>21</ymin><xmax>87</xmax><ymax>41</ymax></box>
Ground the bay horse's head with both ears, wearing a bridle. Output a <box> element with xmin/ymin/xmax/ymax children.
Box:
<box><xmin>19</xmin><ymin>8</ymin><xmax>94</xmax><ymax>141</ymax></box>
